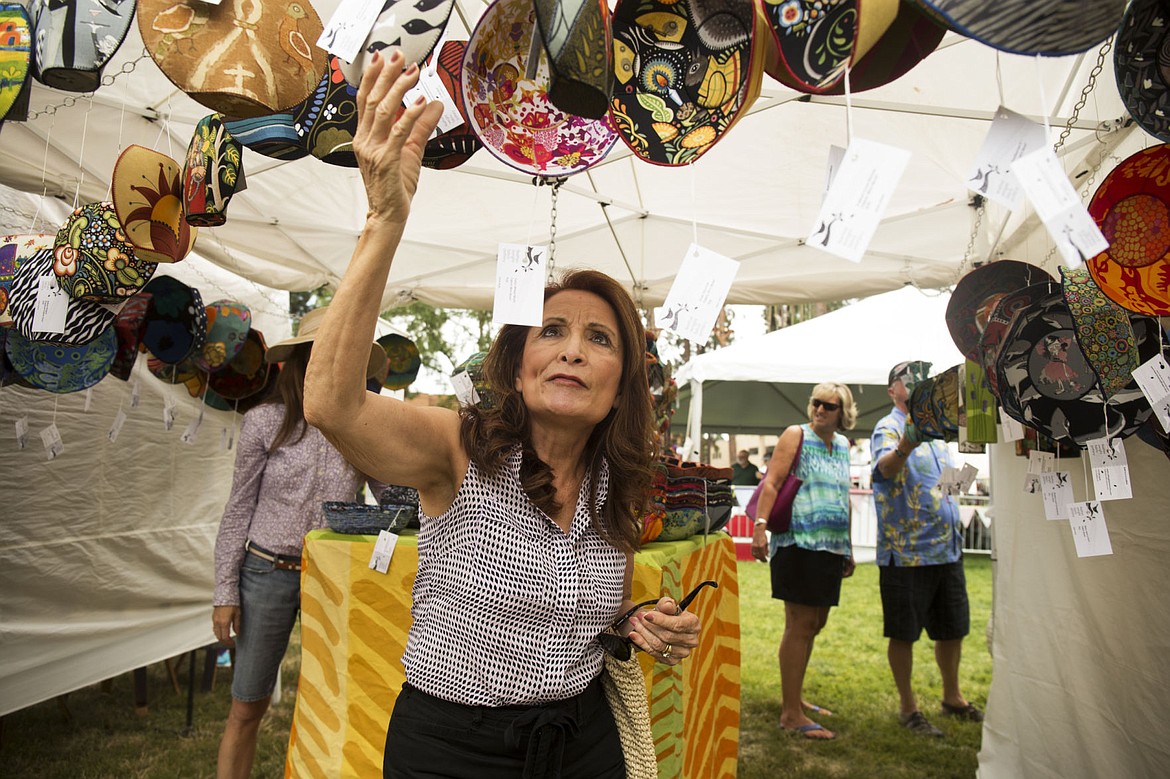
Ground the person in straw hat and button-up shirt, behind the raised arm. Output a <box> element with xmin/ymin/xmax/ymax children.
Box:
<box><xmin>212</xmin><ymin>309</ymin><xmax>386</xmax><ymax>779</ymax></box>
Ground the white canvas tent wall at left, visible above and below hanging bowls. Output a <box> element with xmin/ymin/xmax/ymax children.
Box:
<box><xmin>0</xmin><ymin>256</ymin><xmax>289</xmax><ymax>716</ymax></box>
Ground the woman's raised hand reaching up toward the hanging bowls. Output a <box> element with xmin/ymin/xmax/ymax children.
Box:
<box><xmin>353</xmin><ymin>48</ymin><xmax>442</xmax><ymax>226</ymax></box>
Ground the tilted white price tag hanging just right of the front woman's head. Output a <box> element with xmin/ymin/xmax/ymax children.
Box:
<box><xmin>656</xmin><ymin>243</ymin><xmax>739</xmax><ymax>344</ymax></box>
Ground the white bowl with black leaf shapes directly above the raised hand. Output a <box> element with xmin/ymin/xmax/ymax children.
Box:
<box><xmin>340</xmin><ymin>0</ymin><xmax>455</xmax><ymax>89</ymax></box>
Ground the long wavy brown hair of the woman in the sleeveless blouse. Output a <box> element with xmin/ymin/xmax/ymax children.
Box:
<box><xmin>460</xmin><ymin>270</ymin><xmax>654</xmax><ymax>552</ymax></box>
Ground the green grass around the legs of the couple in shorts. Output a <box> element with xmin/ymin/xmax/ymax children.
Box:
<box><xmin>739</xmin><ymin>557</ymin><xmax>991</xmax><ymax>779</ymax></box>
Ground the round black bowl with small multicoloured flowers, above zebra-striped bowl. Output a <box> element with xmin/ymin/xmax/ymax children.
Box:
<box><xmin>53</xmin><ymin>202</ymin><xmax>157</xmax><ymax>303</ymax></box>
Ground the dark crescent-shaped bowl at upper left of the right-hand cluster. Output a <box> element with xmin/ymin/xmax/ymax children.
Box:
<box><xmin>947</xmin><ymin>260</ymin><xmax>1053</xmax><ymax>360</ymax></box>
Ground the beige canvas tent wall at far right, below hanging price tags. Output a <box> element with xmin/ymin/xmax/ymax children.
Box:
<box><xmin>965</xmin><ymin>439</ymin><xmax>1170</xmax><ymax>779</ymax></box>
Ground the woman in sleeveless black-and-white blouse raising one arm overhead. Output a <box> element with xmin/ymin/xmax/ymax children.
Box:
<box><xmin>305</xmin><ymin>50</ymin><xmax>700</xmax><ymax>779</ymax></box>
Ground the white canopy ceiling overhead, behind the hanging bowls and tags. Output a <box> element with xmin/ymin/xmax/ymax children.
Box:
<box><xmin>0</xmin><ymin>0</ymin><xmax>1150</xmax><ymax>308</ymax></box>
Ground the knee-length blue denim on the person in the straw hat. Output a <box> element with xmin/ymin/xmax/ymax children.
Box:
<box><xmin>232</xmin><ymin>554</ymin><xmax>301</xmax><ymax>702</ymax></box>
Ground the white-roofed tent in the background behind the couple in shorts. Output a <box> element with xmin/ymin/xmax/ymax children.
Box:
<box><xmin>672</xmin><ymin>287</ymin><xmax>963</xmax><ymax>441</ymax></box>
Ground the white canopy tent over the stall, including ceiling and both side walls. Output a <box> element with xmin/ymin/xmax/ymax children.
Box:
<box><xmin>0</xmin><ymin>0</ymin><xmax>1170</xmax><ymax>779</ymax></box>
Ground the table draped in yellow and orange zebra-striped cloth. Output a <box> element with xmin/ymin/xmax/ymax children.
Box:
<box><xmin>284</xmin><ymin>530</ymin><xmax>739</xmax><ymax>779</ymax></box>
